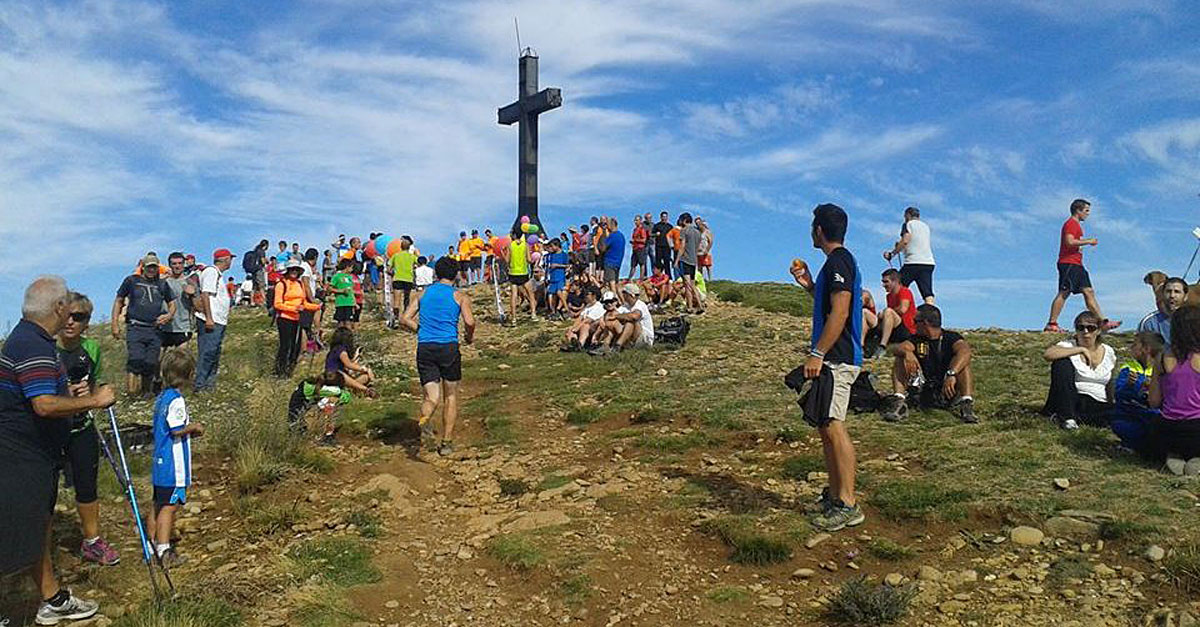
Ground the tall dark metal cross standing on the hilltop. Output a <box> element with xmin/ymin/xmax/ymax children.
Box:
<box><xmin>498</xmin><ymin>48</ymin><xmax>563</xmax><ymax>233</ymax></box>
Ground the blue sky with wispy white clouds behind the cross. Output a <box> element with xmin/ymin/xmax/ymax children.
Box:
<box><xmin>0</xmin><ymin>0</ymin><xmax>1200</xmax><ymax>328</ymax></box>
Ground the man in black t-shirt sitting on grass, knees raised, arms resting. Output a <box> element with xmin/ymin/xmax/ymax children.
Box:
<box><xmin>880</xmin><ymin>305</ymin><xmax>979</xmax><ymax>424</ymax></box>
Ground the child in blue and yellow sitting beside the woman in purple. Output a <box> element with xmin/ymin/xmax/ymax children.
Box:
<box><xmin>1111</xmin><ymin>332</ymin><xmax>1163</xmax><ymax>454</ymax></box>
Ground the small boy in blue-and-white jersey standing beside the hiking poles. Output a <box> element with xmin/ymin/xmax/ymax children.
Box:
<box><xmin>150</xmin><ymin>348</ymin><xmax>204</xmax><ymax>568</ymax></box>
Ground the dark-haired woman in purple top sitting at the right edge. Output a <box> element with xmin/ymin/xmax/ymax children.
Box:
<box><xmin>1150</xmin><ymin>306</ymin><xmax>1200</xmax><ymax>476</ymax></box>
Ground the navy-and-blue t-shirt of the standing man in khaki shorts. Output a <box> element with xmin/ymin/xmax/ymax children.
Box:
<box><xmin>810</xmin><ymin>247</ymin><xmax>863</xmax><ymax>366</ymax></box>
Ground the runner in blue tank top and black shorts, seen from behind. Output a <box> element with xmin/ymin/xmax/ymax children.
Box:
<box><xmin>400</xmin><ymin>257</ymin><xmax>475</xmax><ymax>455</ymax></box>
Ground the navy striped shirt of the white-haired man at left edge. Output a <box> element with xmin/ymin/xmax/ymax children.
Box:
<box><xmin>0</xmin><ymin>320</ymin><xmax>71</xmax><ymax>460</ymax></box>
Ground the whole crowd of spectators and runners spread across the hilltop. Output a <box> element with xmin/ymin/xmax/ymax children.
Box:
<box><xmin>7</xmin><ymin>199</ymin><xmax>1200</xmax><ymax>625</ymax></box>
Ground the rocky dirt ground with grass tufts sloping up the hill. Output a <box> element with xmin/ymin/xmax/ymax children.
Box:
<box><xmin>0</xmin><ymin>284</ymin><xmax>1200</xmax><ymax>627</ymax></box>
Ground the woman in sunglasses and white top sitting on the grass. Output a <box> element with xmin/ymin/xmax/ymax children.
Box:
<box><xmin>1042</xmin><ymin>311</ymin><xmax>1117</xmax><ymax>429</ymax></box>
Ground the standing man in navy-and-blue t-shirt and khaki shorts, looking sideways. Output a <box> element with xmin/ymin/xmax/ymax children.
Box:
<box><xmin>791</xmin><ymin>204</ymin><xmax>865</xmax><ymax>532</ymax></box>
